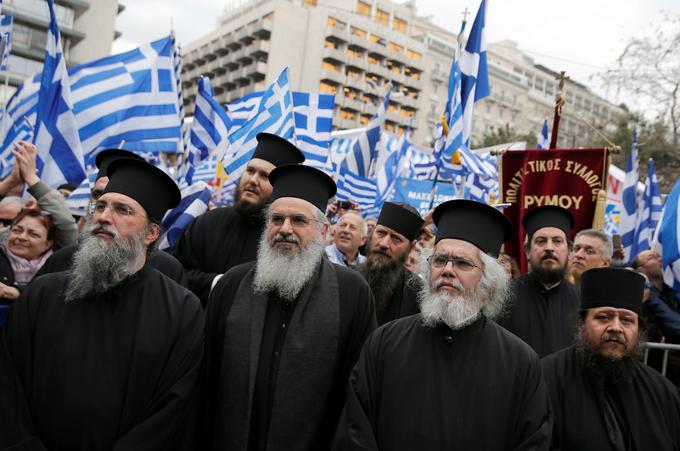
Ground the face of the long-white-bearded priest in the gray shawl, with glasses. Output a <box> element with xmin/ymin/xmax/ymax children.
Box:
<box><xmin>266</xmin><ymin>197</ymin><xmax>327</xmax><ymax>255</ymax></box>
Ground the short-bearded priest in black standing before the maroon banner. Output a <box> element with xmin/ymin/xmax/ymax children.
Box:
<box><xmin>500</xmin><ymin>206</ymin><xmax>579</xmax><ymax>357</ymax></box>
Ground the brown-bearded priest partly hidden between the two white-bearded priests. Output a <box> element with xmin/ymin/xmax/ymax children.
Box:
<box><xmin>357</xmin><ymin>202</ymin><xmax>423</xmax><ymax>325</ymax></box>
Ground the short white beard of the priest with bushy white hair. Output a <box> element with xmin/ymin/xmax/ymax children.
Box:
<box><xmin>418</xmin><ymin>282</ymin><xmax>484</xmax><ymax>330</ymax></box>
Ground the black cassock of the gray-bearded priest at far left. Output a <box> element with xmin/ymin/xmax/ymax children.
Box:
<box><xmin>0</xmin><ymin>265</ymin><xmax>203</xmax><ymax>451</ymax></box>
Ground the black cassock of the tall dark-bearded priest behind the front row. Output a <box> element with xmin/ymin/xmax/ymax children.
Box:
<box><xmin>173</xmin><ymin>207</ymin><xmax>264</xmax><ymax>305</ymax></box>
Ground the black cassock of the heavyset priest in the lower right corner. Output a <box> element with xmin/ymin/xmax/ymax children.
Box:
<box><xmin>541</xmin><ymin>347</ymin><xmax>680</xmax><ymax>451</ymax></box>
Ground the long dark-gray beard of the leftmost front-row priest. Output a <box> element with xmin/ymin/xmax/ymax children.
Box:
<box><xmin>64</xmin><ymin>224</ymin><xmax>146</xmax><ymax>302</ymax></box>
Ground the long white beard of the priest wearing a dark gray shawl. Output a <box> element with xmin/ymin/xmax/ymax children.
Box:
<box><xmin>253</xmin><ymin>232</ymin><xmax>325</xmax><ymax>302</ymax></box>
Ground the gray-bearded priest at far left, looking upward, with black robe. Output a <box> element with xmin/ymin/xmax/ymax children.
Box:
<box><xmin>0</xmin><ymin>158</ymin><xmax>203</xmax><ymax>451</ymax></box>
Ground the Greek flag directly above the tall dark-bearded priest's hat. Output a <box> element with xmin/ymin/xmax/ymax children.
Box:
<box><xmin>222</xmin><ymin>68</ymin><xmax>295</xmax><ymax>180</ymax></box>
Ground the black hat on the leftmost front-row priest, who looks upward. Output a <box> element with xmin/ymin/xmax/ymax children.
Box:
<box><xmin>104</xmin><ymin>158</ymin><xmax>182</xmax><ymax>222</ymax></box>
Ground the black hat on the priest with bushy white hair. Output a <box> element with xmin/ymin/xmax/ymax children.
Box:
<box><xmin>432</xmin><ymin>199</ymin><xmax>512</xmax><ymax>255</ymax></box>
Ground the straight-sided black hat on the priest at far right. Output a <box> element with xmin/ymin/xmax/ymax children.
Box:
<box><xmin>581</xmin><ymin>268</ymin><xmax>645</xmax><ymax>315</ymax></box>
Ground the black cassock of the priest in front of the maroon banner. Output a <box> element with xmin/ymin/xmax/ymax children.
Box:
<box><xmin>499</xmin><ymin>274</ymin><xmax>580</xmax><ymax>357</ymax></box>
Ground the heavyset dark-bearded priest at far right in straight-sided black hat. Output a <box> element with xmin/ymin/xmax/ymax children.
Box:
<box><xmin>541</xmin><ymin>268</ymin><xmax>680</xmax><ymax>451</ymax></box>
